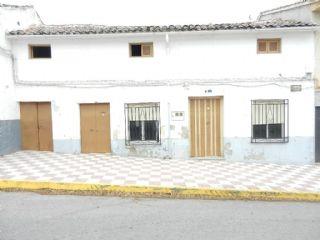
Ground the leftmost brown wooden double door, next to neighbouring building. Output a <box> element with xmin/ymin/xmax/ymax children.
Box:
<box><xmin>20</xmin><ymin>102</ymin><xmax>53</xmax><ymax>151</ymax></box>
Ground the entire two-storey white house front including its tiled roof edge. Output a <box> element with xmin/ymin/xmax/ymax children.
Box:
<box><xmin>2</xmin><ymin>20</ymin><xmax>317</xmax><ymax>164</ymax></box>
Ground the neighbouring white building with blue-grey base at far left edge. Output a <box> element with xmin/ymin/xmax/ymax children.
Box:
<box><xmin>0</xmin><ymin>3</ymin><xmax>42</xmax><ymax>155</ymax></box>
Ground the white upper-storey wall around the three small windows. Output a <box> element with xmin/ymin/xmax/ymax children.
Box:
<box><xmin>12</xmin><ymin>29</ymin><xmax>314</xmax><ymax>81</ymax></box>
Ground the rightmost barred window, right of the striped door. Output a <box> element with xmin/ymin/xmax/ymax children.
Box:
<box><xmin>251</xmin><ymin>100</ymin><xmax>289</xmax><ymax>142</ymax></box>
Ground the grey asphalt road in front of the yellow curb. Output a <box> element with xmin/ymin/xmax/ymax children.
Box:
<box><xmin>0</xmin><ymin>192</ymin><xmax>320</xmax><ymax>240</ymax></box>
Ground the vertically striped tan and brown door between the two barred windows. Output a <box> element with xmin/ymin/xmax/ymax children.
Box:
<box><xmin>189</xmin><ymin>98</ymin><xmax>222</xmax><ymax>157</ymax></box>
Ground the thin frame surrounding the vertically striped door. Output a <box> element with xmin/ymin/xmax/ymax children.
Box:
<box><xmin>188</xmin><ymin>95</ymin><xmax>224</xmax><ymax>159</ymax></box>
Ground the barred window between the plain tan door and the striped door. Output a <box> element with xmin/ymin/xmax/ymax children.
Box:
<box><xmin>125</xmin><ymin>103</ymin><xmax>160</xmax><ymax>146</ymax></box>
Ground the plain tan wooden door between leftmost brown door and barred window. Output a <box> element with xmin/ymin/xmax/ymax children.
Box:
<box><xmin>80</xmin><ymin>103</ymin><xmax>111</xmax><ymax>153</ymax></box>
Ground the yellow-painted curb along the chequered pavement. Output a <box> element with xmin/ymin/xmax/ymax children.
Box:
<box><xmin>0</xmin><ymin>180</ymin><xmax>320</xmax><ymax>202</ymax></box>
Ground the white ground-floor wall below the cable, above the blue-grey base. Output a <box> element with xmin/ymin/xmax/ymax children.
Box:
<box><xmin>17</xmin><ymin>81</ymin><xmax>314</xmax><ymax>139</ymax></box>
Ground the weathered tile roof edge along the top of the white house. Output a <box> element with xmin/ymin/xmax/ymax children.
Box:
<box><xmin>8</xmin><ymin>19</ymin><xmax>318</xmax><ymax>35</ymax></box>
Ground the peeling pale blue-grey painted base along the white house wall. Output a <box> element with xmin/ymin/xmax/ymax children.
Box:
<box><xmin>54</xmin><ymin>137</ymin><xmax>315</xmax><ymax>164</ymax></box>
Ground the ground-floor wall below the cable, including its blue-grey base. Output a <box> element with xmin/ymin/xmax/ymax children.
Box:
<box><xmin>13</xmin><ymin>81</ymin><xmax>314</xmax><ymax>163</ymax></box>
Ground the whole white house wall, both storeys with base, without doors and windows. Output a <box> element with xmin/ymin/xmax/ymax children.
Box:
<box><xmin>8</xmin><ymin>28</ymin><xmax>314</xmax><ymax>163</ymax></box>
